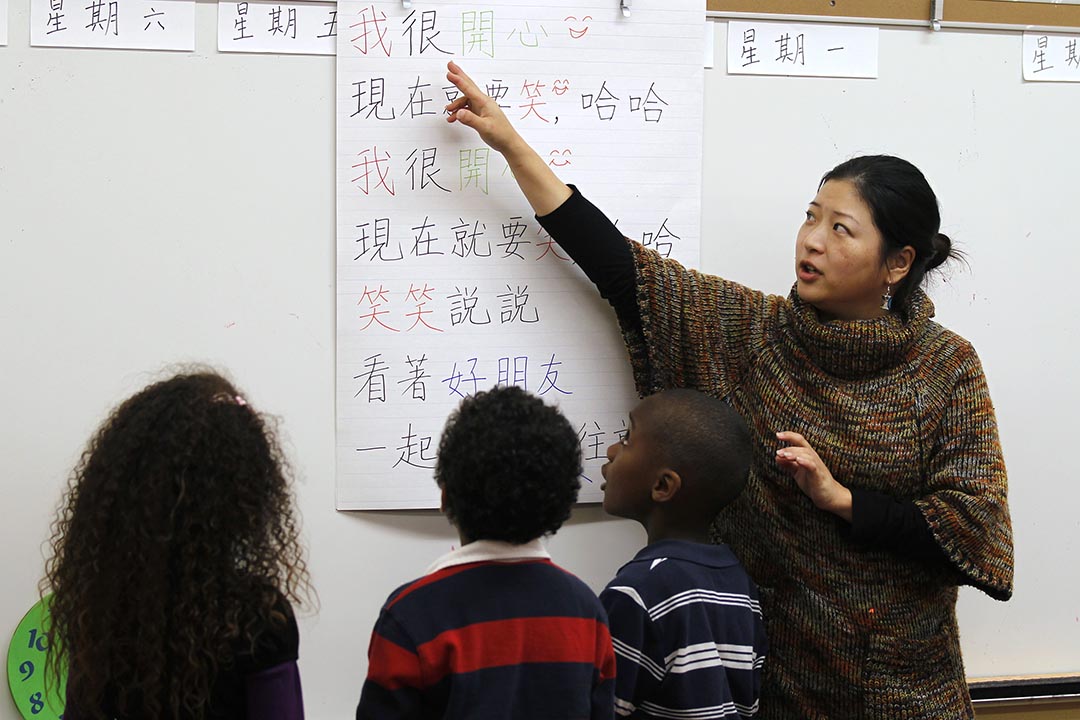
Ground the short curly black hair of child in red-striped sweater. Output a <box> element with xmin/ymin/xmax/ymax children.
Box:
<box><xmin>435</xmin><ymin>386</ymin><xmax>581</xmax><ymax>544</ymax></box>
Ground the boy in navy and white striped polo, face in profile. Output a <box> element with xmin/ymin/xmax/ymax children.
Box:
<box><xmin>600</xmin><ymin>390</ymin><xmax>767</xmax><ymax>720</ymax></box>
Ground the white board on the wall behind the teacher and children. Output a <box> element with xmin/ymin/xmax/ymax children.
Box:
<box><xmin>0</xmin><ymin>8</ymin><xmax>1080</xmax><ymax>720</ymax></box>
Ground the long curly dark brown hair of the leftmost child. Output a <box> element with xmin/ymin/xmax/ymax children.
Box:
<box><xmin>42</xmin><ymin>368</ymin><xmax>311</xmax><ymax>718</ymax></box>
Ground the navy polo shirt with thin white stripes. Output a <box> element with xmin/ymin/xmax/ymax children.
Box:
<box><xmin>600</xmin><ymin>540</ymin><xmax>768</xmax><ymax>720</ymax></box>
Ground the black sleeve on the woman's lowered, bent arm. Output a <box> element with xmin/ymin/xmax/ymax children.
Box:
<box><xmin>851</xmin><ymin>490</ymin><xmax>951</xmax><ymax>567</ymax></box>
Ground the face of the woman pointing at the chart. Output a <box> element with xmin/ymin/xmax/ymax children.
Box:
<box><xmin>795</xmin><ymin>180</ymin><xmax>889</xmax><ymax>320</ymax></box>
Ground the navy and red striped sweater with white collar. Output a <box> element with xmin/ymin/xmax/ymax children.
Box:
<box><xmin>356</xmin><ymin>541</ymin><xmax>616</xmax><ymax>720</ymax></box>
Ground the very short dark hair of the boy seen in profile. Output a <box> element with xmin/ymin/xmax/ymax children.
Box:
<box><xmin>649</xmin><ymin>388</ymin><xmax>753</xmax><ymax>517</ymax></box>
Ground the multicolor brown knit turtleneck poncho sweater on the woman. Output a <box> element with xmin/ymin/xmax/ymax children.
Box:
<box><xmin>623</xmin><ymin>243</ymin><xmax>1013</xmax><ymax>720</ymax></box>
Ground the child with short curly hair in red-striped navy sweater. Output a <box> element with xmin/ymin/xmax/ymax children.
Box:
<box><xmin>356</xmin><ymin>386</ymin><xmax>615</xmax><ymax>720</ymax></box>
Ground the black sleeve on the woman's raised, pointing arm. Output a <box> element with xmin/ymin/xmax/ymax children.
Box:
<box><xmin>537</xmin><ymin>185</ymin><xmax>642</xmax><ymax>327</ymax></box>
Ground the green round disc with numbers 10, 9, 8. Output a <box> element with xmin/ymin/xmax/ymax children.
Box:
<box><xmin>8</xmin><ymin>596</ymin><xmax>66</xmax><ymax>720</ymax></box>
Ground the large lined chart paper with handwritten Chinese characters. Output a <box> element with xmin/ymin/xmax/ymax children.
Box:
<box><xmin>337</xmin><ymin>0</ymin><xmax>704</xmax><ymax>510</ymax></box>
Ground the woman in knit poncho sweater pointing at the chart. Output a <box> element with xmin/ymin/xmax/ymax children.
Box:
<box><xmin>446</xmin><ymin>63</ymin><xmax>1013</xmax><ymax>720</ymax></box>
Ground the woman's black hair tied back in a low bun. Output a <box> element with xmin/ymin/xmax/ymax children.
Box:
<box><xmin>818</xmin><ymin>155</ymin><xmax>963</xmax><ymax>307</ymax></box>
